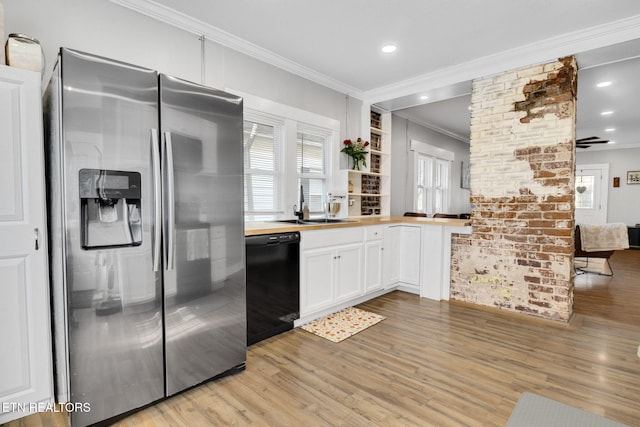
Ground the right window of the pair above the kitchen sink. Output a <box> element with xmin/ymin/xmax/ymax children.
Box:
<box><xmin>296</xmin><ymin>127</ymin><xmax>329</xmax><ymax>214</ymax></box>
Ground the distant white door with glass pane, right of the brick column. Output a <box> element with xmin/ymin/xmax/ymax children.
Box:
<box><xmin>575</xmin><ymin>164</ymin><xmax>609</xmax><ymax>224</ymax></box>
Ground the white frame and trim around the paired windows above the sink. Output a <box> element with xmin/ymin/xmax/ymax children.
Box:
<box><xmin>231</xmin><ymin>88</ymin><xmax>340</xmax><ymax>221</ymax></box>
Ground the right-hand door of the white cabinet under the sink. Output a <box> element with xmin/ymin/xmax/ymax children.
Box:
<box><xmin>335</xmin><ymin>244</ymin><xmax>363</xmax><ymax>302</ymax></box>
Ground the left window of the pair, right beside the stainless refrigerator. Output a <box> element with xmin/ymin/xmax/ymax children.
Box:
<box><xmin>244</xmin><ymin>118</ymin><xmax>283</xmax><ymax>221</ymax></box>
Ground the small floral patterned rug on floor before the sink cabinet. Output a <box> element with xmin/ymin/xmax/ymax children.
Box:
<box><xmin>301</xmin><ymin>307</ymin><xmax>386</xmax><ymax>342</ymax></box>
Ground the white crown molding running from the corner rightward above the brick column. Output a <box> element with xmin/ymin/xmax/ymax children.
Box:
<box><xmin>363</xmin><ymin>15</ymin><xmax>640</xmax><ymax>104</ymax></box>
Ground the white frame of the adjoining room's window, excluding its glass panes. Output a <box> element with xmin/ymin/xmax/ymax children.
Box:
<box><xmin>409</xmin><ymin>140</ymin><xmax>455</xmax><ymax>216</ymax></box>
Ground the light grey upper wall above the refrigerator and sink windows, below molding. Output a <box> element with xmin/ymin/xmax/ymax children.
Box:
<box><xmin>3</xmin><ymin>0</ymin><xmax>361</xmax><ymax>135</ymax></box>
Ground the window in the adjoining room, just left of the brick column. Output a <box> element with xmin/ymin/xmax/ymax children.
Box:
<box><xmin>411</xmin><ymin>141</ymin><xmax>453</xmax><ymax>215</ymax></box>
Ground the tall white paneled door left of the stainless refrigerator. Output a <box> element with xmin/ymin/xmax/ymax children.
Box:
<box><xmin>0</xmin><ymin>66</ymin><xmax>53</xmax><ymax>424</ymax></box>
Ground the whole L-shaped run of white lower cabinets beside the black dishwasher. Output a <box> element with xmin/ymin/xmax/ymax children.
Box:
<box><xmin>296</xmin><ymin>224</ymin><xmax>471</xmax><ymax>325</ymax></box>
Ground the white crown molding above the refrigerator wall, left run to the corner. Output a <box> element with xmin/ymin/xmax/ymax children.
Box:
<box><xmin>109</xmin><ymin>0</ymin><xmax>363</xmax><ymax>99</ymax></box>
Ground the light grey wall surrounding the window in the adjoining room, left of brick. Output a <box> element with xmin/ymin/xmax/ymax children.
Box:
<box><xmin>391</xmin><ymin>114</ymin><xmax>471</xmax><ymax>215</ymax></box>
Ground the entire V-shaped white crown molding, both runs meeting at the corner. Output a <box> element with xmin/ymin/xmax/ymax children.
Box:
<box><xmin>109</xmin><ymin>0</ymin><xmax>640</xmax><ymax>105</ymax></box>
